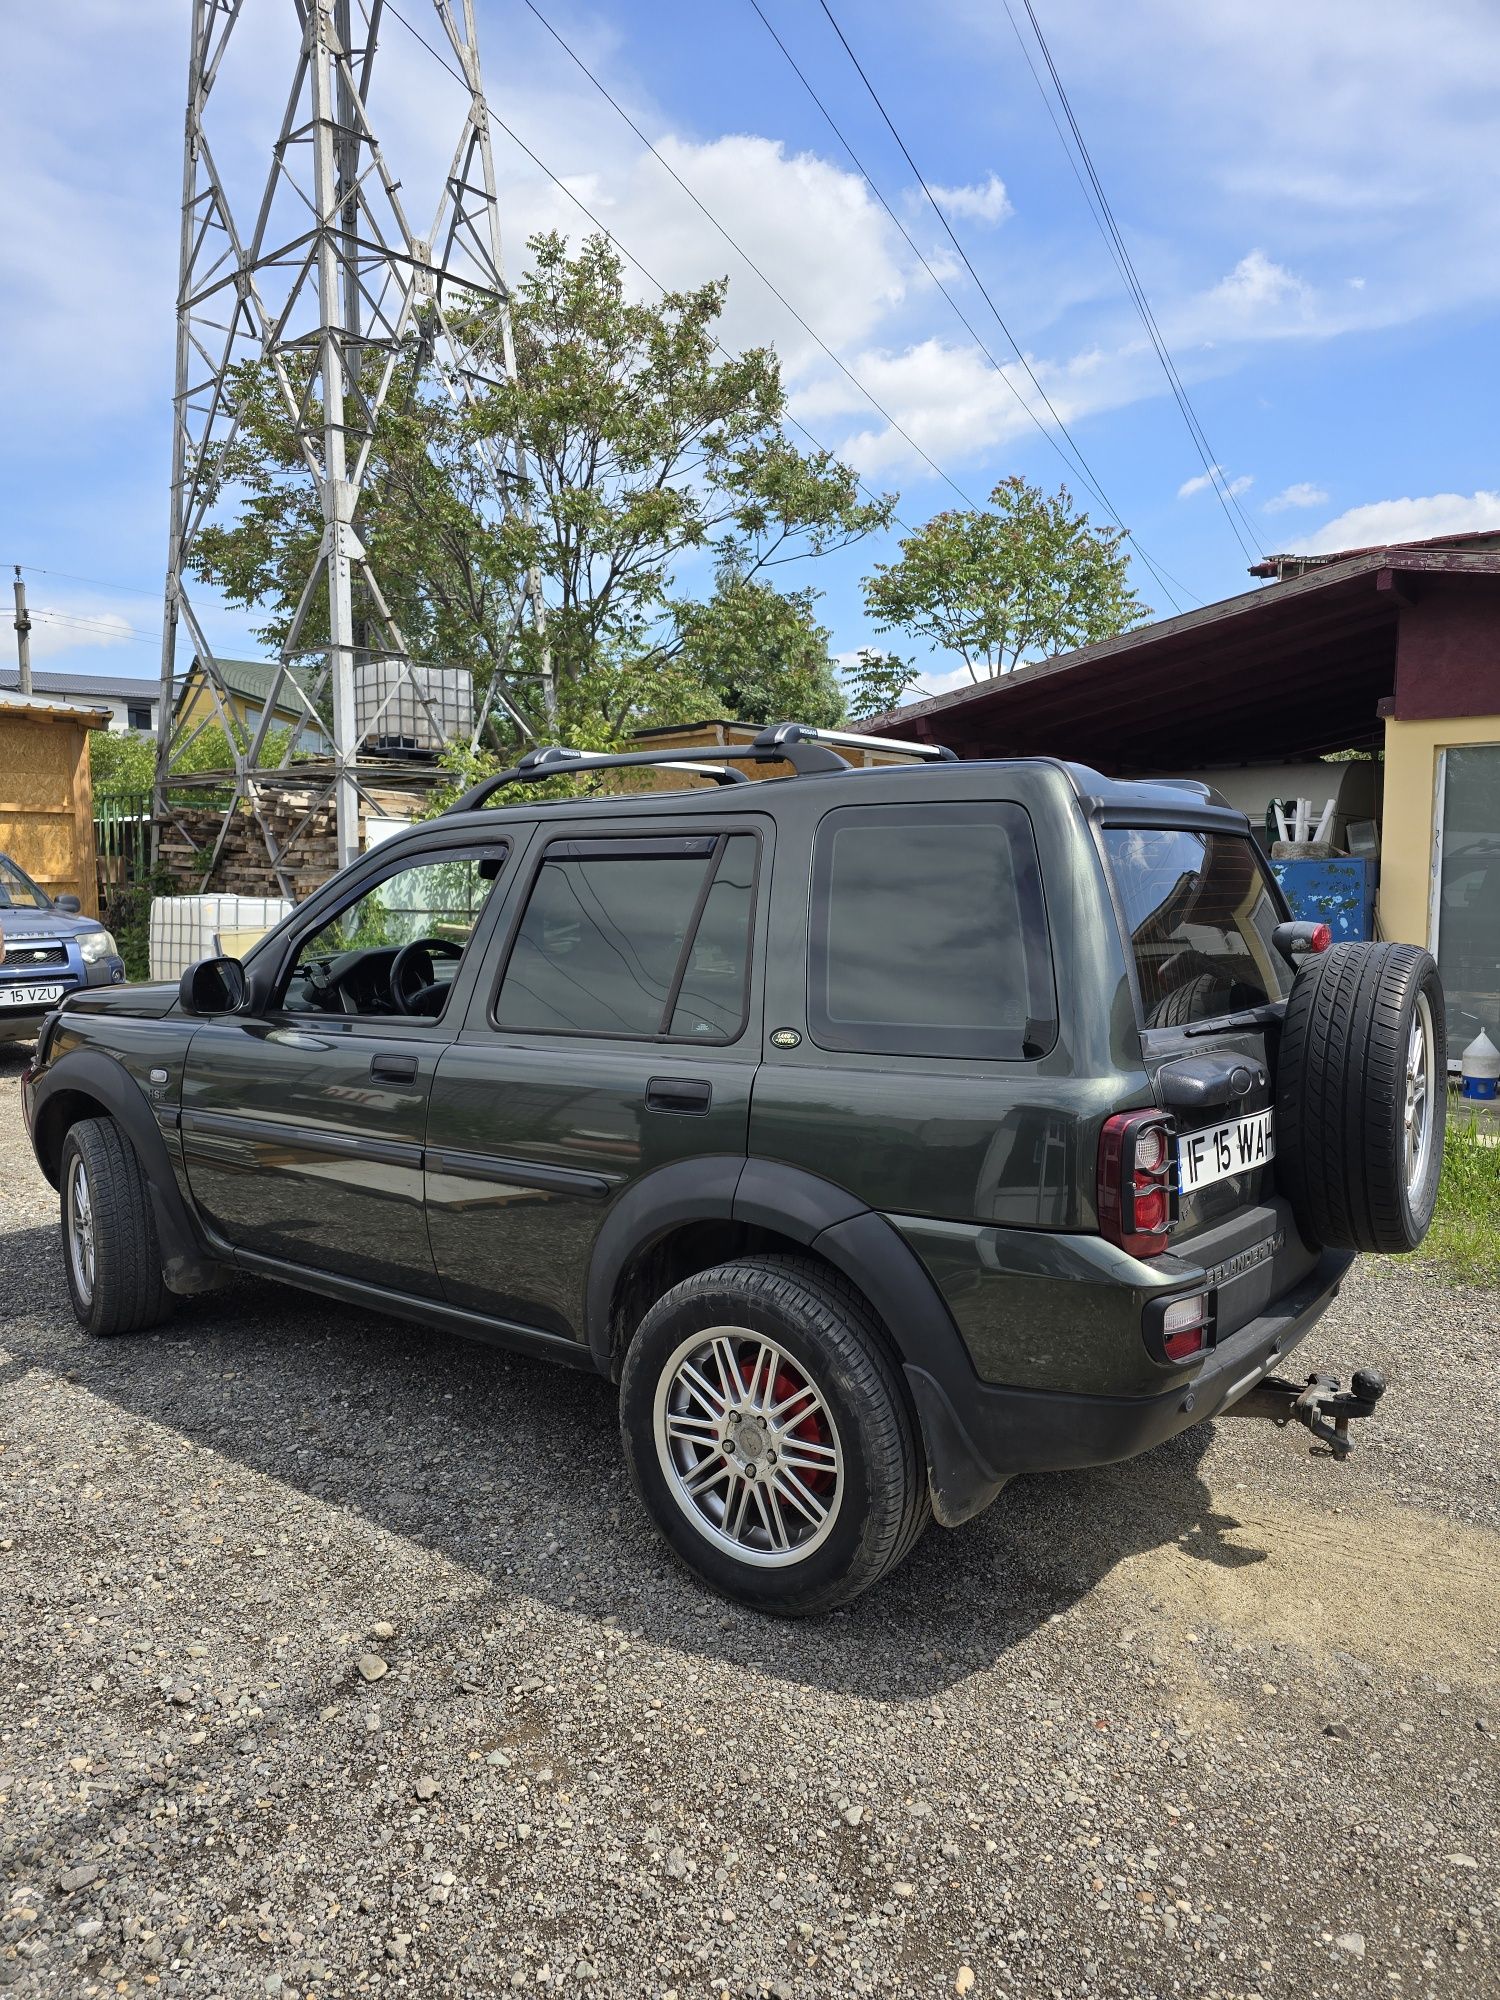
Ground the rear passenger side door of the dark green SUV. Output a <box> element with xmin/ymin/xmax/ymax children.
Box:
<box><xmin>426</xmin><ymin>814</ymin><xmax>772</xmax><ymax>1338</ymax></box>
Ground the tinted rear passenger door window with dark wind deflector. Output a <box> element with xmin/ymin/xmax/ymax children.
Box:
<box><xmin>494</xmin><ymin>834</ymin><xmax>758</xmax><ymax>1042</ymax></box>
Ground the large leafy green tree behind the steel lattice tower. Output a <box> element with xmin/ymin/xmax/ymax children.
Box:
<box><xmin>196</xmin><ymin>234</ymin><xmax>894</xmax><ymax>748</ymax></box>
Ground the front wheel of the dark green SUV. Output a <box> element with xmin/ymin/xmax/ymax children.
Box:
<box><xmin>58</xmin><ymin>1118</ymin><xmax>172</xmax><ymax>1336</ymax></box>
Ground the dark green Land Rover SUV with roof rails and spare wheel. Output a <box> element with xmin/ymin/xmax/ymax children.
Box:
<box><xmin>24</xmin><ymin>724</ymin><xmax>1446</xmax><ymax>1612</ymax></box>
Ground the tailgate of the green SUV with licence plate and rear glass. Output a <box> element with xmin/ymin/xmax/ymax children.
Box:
<box><xmin>1102</xmin><ymin>826</ymin><xmax>1314</xmax><ymax>1336</ymax></box>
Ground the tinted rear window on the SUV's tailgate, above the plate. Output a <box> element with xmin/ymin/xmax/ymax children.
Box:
<box><xmin>1104</xmin><ymin>826</ymin><xmax>1292</xmax><ymax>1028</ymax></box>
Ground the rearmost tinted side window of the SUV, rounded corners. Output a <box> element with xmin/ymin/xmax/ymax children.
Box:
<box><xmin>808</xmin><ymin>802</ymin><xmax>1058</xmax><ymax>1060</ymax></box>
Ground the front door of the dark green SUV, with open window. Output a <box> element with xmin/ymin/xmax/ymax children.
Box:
<box><xmin>182</xmin><ymin>842</ymin><xmax>506</xmax><ymax>1296</ymax></box>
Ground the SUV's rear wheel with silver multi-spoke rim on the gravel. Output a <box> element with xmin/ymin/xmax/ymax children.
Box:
<box><xmin>620</xmin><ymin>1256</ymin><xmax>932</xmax><ymax>1618</ymax></box>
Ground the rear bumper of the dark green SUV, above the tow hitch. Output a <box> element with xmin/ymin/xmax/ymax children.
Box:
<box><xmin>906</xmin><ymin>1250</ymin><xmax>1354</xmax><ymax>1526</ymax></box>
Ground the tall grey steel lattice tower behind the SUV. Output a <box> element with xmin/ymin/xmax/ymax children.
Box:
<box><xmin>156</xmin><ymin>0</ymin><xmax>552</xmax><ymax>892</ymax></box>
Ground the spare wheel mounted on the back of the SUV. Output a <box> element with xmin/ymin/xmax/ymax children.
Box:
<box><xmin>1276</xmin><ymin>944</ymin><xmax>1448</xmax><ymax>1254</ymax></box>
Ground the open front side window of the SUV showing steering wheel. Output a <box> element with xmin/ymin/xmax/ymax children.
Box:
<box><xmin>282</xmin><ymin>844</ymin><xmax>506</xmax><ymax>1018</ymax></box>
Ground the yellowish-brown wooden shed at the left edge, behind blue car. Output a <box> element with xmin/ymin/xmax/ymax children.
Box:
<box><xmin>0</xmin><ymin>692</ymin><xmax>110</xmax><ymax>916</ymax></box>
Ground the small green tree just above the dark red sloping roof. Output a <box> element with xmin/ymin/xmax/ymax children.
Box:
<box><xmin>864</xmin><ymin>478</ymin><xmax>1146</xmax><ymax>682</ymax></box>
